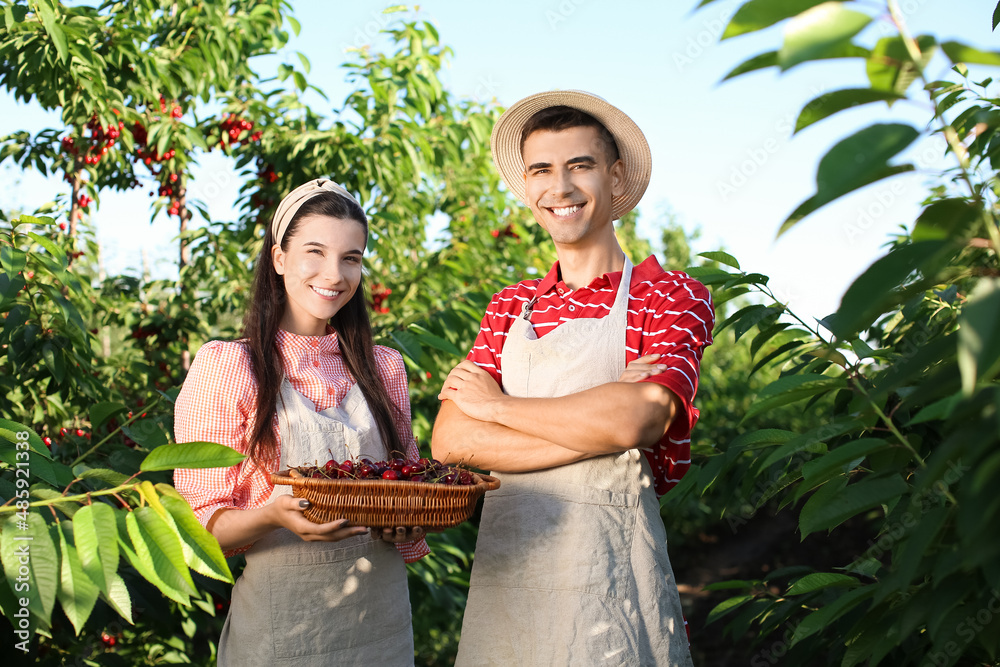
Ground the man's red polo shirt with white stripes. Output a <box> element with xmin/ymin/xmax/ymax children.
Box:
<box><xmin>468</xmin><ymin>256</ymin><xmax>715</xmax><ymax>495</ymax></box>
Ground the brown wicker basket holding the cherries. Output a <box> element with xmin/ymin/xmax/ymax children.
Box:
<box><xmin>271</xmin><ymin>470</ymin><xmax>500</xmax><ymax>528</ymax></box>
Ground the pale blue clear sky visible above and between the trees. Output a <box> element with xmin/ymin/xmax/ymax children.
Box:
<box><xmin>0</xmin><ymin>0</ymin><xmax>1000</xmax><ymax>324</ymax></box>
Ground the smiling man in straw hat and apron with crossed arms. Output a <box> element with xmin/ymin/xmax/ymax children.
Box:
<box><xmin>432</xmin><ymin>91</ymin><xmax>714</xmax><ymax>666</ymax></box>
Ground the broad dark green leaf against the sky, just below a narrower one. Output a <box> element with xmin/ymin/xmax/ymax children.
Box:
<box><xmin>778</xmin><ymin>123</ymin><xmax>920</xmax><ymax>236</ymax></box>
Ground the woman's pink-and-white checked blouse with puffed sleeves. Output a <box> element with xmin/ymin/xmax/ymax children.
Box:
<box><xmin>174</xmin><ymin>331</ymin><xmax>430</xmax><ymax>563</ymax></box>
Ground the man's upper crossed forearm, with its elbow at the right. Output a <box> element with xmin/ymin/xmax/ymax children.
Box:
<box><xmin>492</xmin><ymin>382</ymin><xmax>679</xmax><ymax>455</ymax></box>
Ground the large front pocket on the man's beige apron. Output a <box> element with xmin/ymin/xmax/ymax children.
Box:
<box><xmin>472</xmin><ymin>485</ymin><xmax>639</xmax><ymax>599</ymax></box>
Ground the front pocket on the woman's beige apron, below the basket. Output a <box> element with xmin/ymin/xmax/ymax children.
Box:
<box><xmin>269</xmin><ymin>541</ymin><xmax>412</xmax><ymax>658</ymax></box>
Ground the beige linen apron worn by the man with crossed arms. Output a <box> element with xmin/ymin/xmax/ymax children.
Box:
<box><xmin>456</xmin><ymin>258</ymin><xmax>691</xmax><ymax>667</ymax></box>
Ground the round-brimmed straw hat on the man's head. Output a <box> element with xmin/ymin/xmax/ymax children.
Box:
<box><xmin>490</xmin><ymin>90</ymin><xmax>653</xmax><ymax>220</ymax></box>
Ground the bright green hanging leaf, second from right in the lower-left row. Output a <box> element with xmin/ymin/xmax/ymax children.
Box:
<box><xmin>125</xmin><ymin>507</ymin><xmax>196</xmax><ymax>604</ymax></box>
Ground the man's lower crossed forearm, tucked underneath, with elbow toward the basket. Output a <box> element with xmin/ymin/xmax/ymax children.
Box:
<box><xmin>431</xmin><ymin>401</ymin><xmax>594</xmax><ymax>472</ymax></box>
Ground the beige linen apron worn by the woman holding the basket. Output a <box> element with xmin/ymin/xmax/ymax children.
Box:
<box><xmin>219</xmin><ymin>378</ymin><xmax>413</xmax><ymax>667</ymax></box>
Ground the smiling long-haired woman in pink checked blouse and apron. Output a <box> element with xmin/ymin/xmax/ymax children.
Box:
<box><xmin>174</xmin><ymin>179</ymin><xmax>428</xmax><ymax>666</ymax></box>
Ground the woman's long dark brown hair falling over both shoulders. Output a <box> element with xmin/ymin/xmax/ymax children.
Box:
<box><xmin>243</xmin><ymin>192</ymin><xmax>403</xmax><ymax>464</ymax></box>
